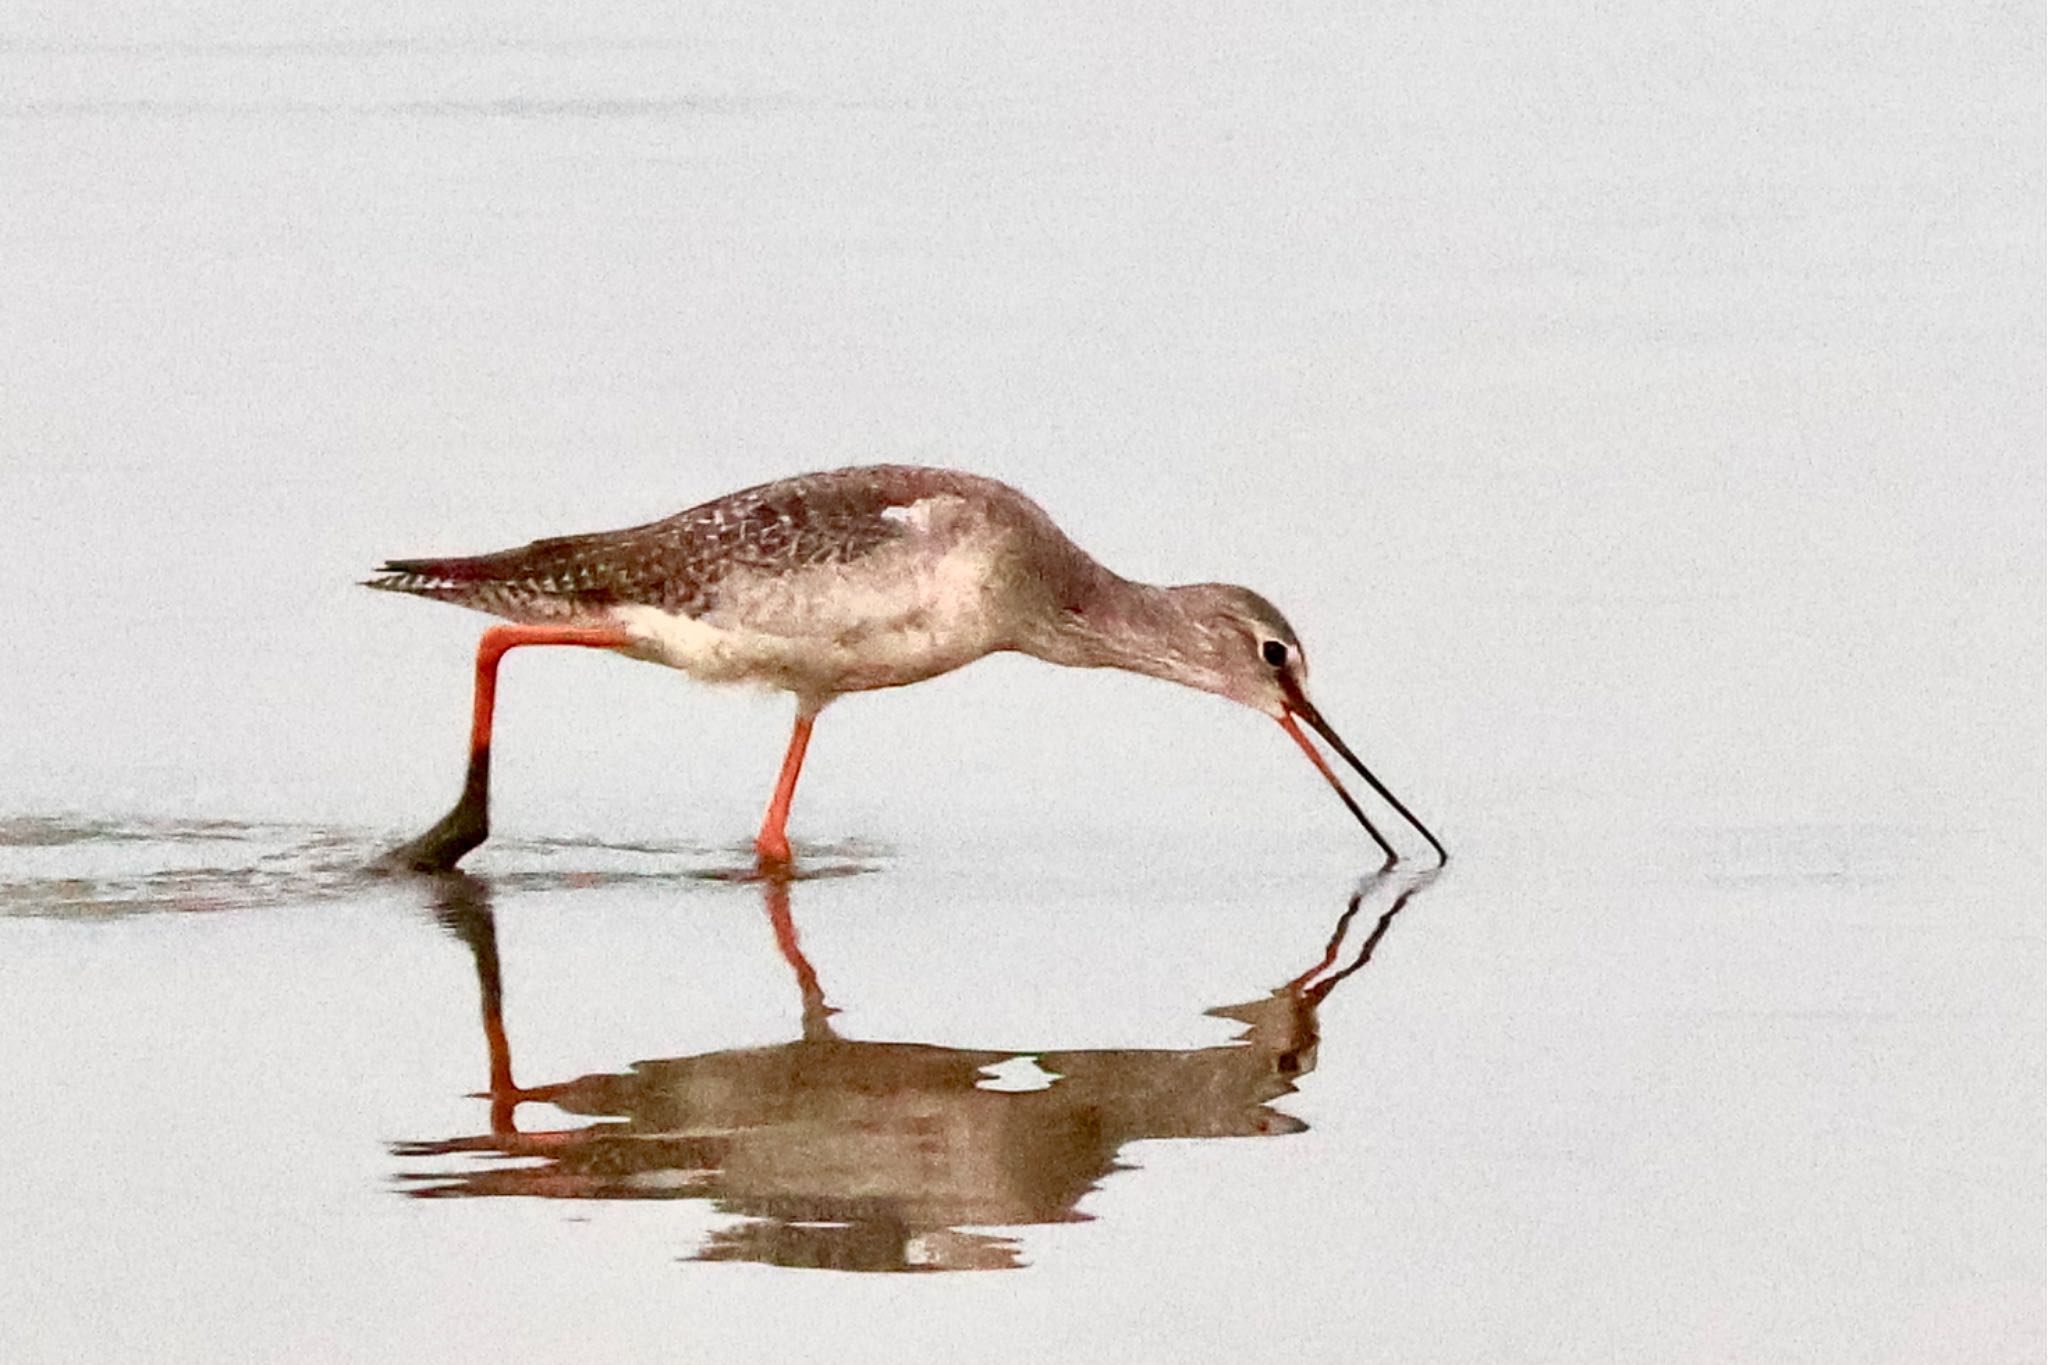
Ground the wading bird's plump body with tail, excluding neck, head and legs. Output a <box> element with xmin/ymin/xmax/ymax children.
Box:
<box><xmin>371</xmin><ymin>465</ymin><xmax>1102</xmax><ymax>692</ymax></box>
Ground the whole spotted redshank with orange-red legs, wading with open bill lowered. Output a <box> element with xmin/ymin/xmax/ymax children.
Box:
<box><xmin>369</xmin><ymin>465</ymin><xmax>1446</xmax><ymax>872</ymax></box>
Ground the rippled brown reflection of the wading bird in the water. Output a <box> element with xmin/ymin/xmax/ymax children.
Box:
<box><xmin>393</xmin><ymin>874</ymin><xmax>1430</xmax><ymax>1271</ymax></box>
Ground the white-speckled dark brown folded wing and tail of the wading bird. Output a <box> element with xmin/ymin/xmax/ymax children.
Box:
<box><xmin>369</xmin><ymin>465</ymin><xmax>948</xmax><ymax>620</ymax></box>
